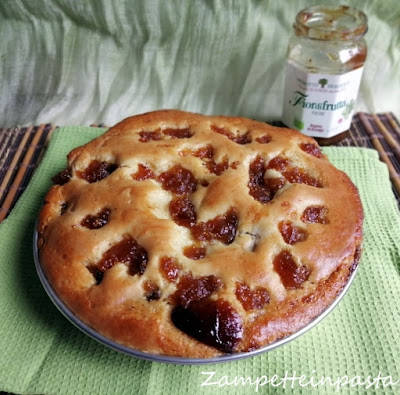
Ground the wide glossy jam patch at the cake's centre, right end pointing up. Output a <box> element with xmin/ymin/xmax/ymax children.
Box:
<box><xmin>191</xmin><ymin>208</ymin><xmax>239</xmax><ymax>245</ymax></box>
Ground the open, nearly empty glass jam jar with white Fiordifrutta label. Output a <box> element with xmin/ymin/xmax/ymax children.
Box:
<box><xmin>282</xmin><ymin>5</ymin><xmax>368</xmax><ymax>145</ymax></box>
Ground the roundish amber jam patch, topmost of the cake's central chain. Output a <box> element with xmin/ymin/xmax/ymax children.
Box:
<box><xmin>159</xmin><ymin>165</ymin><xmax>197</xmax><ymax>195</ymax></box>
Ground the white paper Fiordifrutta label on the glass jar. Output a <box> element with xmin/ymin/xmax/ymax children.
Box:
<box><xmin>282</xmin><ymin>63</ymin><xmax>363</xmax><ymax>138</ymax></box>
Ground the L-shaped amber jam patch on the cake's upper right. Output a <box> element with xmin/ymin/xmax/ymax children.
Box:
<box><xmin>247</xmin><ymin>156</ymin><xmax>286</xmax><ymax>203</ymax></box>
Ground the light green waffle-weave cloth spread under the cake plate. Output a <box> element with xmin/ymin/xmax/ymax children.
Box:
<box><xmin>0</xmin><ymin>127</ymin><xmax>400</xmax><ymax>394</ymax></box>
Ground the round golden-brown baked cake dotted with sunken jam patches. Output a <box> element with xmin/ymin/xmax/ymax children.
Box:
<box><xmin>37</xmin><ymin>110</ymin><xmax>363</xmax><ymax>358</ymax></box>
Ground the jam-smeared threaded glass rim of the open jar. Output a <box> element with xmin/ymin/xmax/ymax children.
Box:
<box><xmin>293</xmin><ymin>5</ymin><xmax>368</xmax><ymax>41</ymax></box>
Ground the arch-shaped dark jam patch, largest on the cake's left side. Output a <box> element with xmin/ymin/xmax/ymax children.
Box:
<box><xmin>96</xmin><ymin>236</ymin><xmax>148</xmax><ymax>276</ymax></box>
